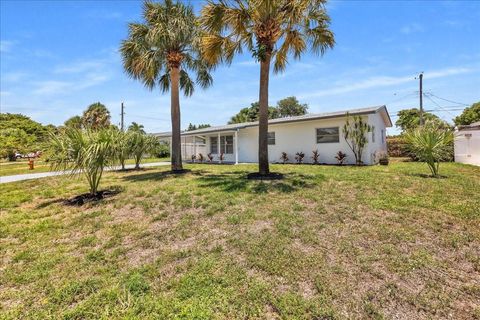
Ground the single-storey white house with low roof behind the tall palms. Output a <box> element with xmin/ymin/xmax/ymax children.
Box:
<box><xmin>154</xmin><ymin>106</ymin><xmax>392</xmax><ymax>164</ymax></box>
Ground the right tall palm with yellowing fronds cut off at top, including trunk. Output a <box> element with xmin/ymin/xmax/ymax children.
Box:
<box><xmin>200</xmin><ymin>0</ymin><xmax>335</xmax><ymax>175</ymax></box>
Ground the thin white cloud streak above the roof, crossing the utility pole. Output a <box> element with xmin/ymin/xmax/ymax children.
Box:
<box><xmin>299</xmin><ymin>67</ymin><xmax>477</xmax><ymax>99</ymax></box>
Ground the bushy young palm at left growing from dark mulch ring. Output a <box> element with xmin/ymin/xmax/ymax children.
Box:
<box><xmin>49</xmin><ymin>128</ymin><xmax>119</xmax><ymax>195</ymax></box>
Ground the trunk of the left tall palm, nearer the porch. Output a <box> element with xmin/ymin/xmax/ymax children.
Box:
<box><xmin>170</xmin><ymin>67</ymin><xmax>183</xmax><ymax>171</ymax></box>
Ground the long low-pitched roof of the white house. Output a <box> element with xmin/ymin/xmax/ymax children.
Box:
<box><xmin>153</xmin><ymin>105</ymin><xmax>392</xmax><ymax>137</ymax></box>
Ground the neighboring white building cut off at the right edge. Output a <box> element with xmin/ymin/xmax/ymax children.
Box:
<box><xmin>454</xmin><ymin>121</ymin><xmax>480</xmax><ymax>166</ymax></box>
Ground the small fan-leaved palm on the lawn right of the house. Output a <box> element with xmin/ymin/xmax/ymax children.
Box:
<box><xmin>405</xmin><ymin>122</ymin><xmax>453</xmax><ymax>177</ymax></box>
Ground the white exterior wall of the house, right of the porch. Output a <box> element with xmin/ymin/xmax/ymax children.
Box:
<box><xmin>238</xmin><ymin>113</ymin><xmax>386</xmax><ymax>164</ymax></box>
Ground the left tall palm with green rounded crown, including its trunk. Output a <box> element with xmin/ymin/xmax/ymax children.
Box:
<box><xmin>120</xmin><ymin>0</ymin><xmax>212</xmax><ymax>171</ymax></box>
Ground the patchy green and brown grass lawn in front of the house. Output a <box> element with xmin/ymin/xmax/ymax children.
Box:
<box><xmin>0</xmin><ymin>163</ymin><xmax>480</xmax><ymax>319</ymax></box>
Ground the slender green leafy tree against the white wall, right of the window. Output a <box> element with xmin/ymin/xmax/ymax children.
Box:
<box><xmin>342</xmin><ymin>115</ymin><xmax>373</xmax><ymax>165</ymax></box>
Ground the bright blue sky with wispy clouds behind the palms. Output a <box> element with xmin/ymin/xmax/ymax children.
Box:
<box><xmin>0</xmin><ymin>0</ymin><xmax>480</xmax><ymax>134</ymax></box>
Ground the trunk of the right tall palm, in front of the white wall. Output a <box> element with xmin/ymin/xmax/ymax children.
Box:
<box><xmin>258</xmin><ymin>52</ymin><xmax>271</xmax><ymax>175</ymax></box>
